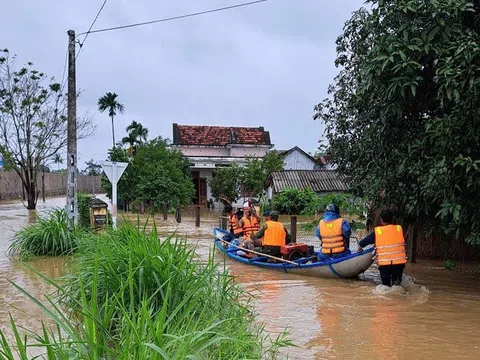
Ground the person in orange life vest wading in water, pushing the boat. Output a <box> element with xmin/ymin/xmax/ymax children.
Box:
<box><xmin>358</xmin><ymin>210</ymin><xmax>407</xmax><ymax>286</ymax></box>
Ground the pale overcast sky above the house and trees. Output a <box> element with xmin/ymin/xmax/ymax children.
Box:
<box><xmin>0</xmin><ymin>0</ymin><xmax>363</xmax><ymax>168</ymax></box>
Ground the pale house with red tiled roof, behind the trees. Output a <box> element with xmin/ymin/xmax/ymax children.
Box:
<box><xmin>172</xmin><ymin>124</ymin><xmax>273</xmax><ymax>204</ymax></box>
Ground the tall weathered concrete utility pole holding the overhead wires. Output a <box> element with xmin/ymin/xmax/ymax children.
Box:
<box><xmin>66</xmin><ymin>30</ymin><xmax>78</xmax><ymax>226</ymax></box>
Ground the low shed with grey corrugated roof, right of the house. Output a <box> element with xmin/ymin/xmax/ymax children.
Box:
<box><xmin>265</xmin><ymin>170</ymin><xmax>348</xmax><ymax>200</ymax></box>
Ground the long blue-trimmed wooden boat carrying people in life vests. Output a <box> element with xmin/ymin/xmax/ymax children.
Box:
<box><xmin>213</xmin><ymin>228</ymin><xmax>374</xmax><ymax>278</ymax></box>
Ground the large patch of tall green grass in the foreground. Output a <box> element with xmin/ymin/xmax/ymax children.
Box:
<box><xmin>0</xmin><ymin>224</ymin><xmax>288</xmax><ymax>359</ymax></box>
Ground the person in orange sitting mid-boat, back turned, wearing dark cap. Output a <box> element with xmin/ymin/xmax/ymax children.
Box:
<box><xmin>249</xmin><ymin>211</ymin><xmax>291</xmax><ymax>256</ymax></box>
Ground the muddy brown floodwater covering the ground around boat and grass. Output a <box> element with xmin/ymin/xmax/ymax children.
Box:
<box><xmin>0</xmin><ymin>198</ymin><xmax>480</xmax><ymax>360</ymax></box>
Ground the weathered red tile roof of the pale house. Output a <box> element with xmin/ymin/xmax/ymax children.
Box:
<box><xmin>173</xmin><ymin>124</ymin><xmax>271</xmax><ymax>146</ymax></box>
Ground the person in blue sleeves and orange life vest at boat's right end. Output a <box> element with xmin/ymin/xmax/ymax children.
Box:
<box><xmin>315</xmin><ymin>204</ymin><xmax>352</xmax><ymax>259</ymax></box>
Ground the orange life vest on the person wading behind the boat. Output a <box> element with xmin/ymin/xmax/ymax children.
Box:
<box><xmin>375</xmin><ymin>225</ymin><xmax>407</xmax><ymax>266</ymax></box>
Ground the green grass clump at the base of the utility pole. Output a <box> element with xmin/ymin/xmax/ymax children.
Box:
<box><xmin>8</xmin><ymin>209</ymin><xmax>85</xmax><ymax>260</ymax></box>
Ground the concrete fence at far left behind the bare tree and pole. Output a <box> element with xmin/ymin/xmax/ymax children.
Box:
<box><xmin>0</xmin><ymin>170</ymin><xmax>102</xmax><ymax>200</ymax></box>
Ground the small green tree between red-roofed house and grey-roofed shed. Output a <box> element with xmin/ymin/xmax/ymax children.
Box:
<box><xmin>241</xmin><ymin>152</ymin><xmax>284</xmax><ymax>196</ymax></box>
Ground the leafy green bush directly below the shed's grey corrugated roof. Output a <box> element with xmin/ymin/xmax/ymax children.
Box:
<box><xmin>272</xmin><ymin>189</ymin><xmax>318</xmax><ymax>215</ymax></box>
